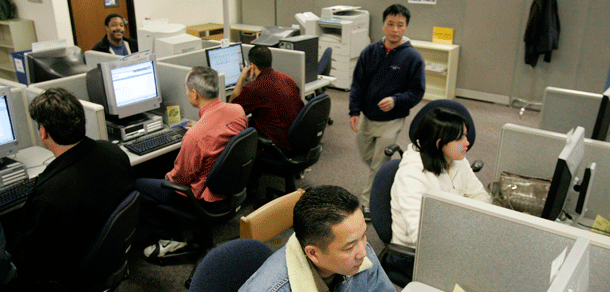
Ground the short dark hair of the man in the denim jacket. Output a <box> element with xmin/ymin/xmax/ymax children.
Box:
<box><xmin>293</xmin><ymin>186</ymin><xmax>360</xmax><ymax>250</ymax></box>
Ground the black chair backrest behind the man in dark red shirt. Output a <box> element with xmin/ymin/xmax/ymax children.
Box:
<box><xmin>287</xmin><ymin>94</ymin><xmax>330</xmax><ymax>153</ymax></box>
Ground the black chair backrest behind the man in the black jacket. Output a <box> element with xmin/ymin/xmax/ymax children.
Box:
<box><xmin>79</xmin><ymin>191</ymin><xmax>140</xmax><ymax>284</ymax></box>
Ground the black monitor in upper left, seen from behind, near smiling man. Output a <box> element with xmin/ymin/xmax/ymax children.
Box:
<box><xmin>25</xmin><ymin>46</ymin><xmax>89</xmax><ymax>84</ymax></box>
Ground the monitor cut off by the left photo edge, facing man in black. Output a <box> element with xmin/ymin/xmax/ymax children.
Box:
<box><xmin>0</xmin><ymin>87</ymin><xmax>19</xmax><ymax>165</ymax></box>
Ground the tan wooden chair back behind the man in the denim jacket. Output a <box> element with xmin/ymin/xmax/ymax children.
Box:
<box><xmin>239</xmin><ymin>189</ymin><xmax>305</xmax><ymax>242</ymax></box>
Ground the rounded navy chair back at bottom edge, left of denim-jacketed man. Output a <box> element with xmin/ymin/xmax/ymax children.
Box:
<box><xmin>189</xmin><ymin>238</ymin><xmax>273</xmax><ymax>292</ymax></box>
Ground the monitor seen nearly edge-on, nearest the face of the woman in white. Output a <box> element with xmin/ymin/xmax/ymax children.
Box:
<box><xmin>541</xmin><ymin>127</ymin><xmax>585</xmax><ymax>221</ymax></box>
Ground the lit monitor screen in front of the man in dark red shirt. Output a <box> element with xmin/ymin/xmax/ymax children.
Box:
<box><xmin>205</xmin><ymin>44</ymin><xmax>244</xmax><ymax>88</ymax></box>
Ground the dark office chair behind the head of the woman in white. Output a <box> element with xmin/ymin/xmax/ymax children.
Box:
<box><xmin>385</xmin><ymin>99</ymin><xmax>484</xmax><ymax>172</ymax></box>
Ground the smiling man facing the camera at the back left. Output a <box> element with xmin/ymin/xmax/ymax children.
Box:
<box><xmin>91</xmin><ymin>13</ymin><xmax>138</xmax><ymax>56</ymax></box>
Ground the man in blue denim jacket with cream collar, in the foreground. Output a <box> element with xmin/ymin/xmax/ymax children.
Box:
<box><xmin>239</xmin><ymin>186</ymin><xmax>396</xmax><ymax>292</ymax></box>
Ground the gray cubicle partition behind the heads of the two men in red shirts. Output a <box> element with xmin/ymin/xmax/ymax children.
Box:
<box><xmin>158</xmin><ymin>44</ymin><xmax>305</xmax><ymax>101</ymax></box>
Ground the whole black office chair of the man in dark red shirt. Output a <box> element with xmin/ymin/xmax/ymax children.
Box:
<box><xmin>256</xmin><ymin>94</ymin><xmax>330</xmax><ymax>200</ymax></box>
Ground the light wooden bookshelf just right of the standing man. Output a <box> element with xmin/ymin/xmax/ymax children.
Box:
<box><xmin>411</xmin><ymin>40</ymin><xmax>460</xmax><ymax>100</ymax></box>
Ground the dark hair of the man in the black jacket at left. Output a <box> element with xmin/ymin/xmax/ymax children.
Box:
<box><xmin>29</xmin><ymin>88</ymin><xmax>85</xmax><ymax>145</ymax></box>
